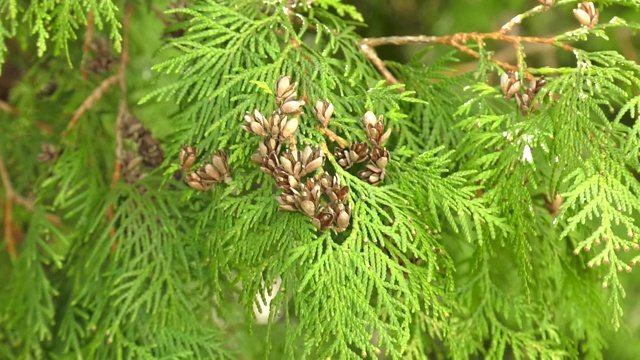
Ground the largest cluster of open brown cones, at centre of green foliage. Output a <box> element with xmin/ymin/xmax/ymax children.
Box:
<box><xmin>242</xmin><ymin>76</ymin><xmax>351</xmax><ymax>232</ymax></box>
